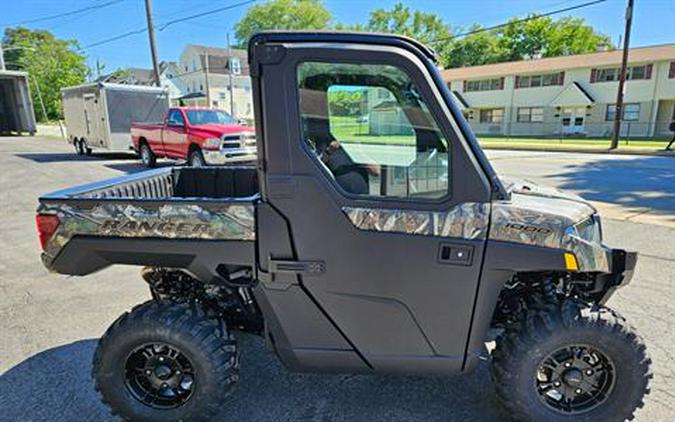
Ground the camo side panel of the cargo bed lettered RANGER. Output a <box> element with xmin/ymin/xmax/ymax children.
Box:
<box><xmin>38</xmin><ymin>201</ymin><xmax>255</xmax><ymax>257</ymax></box>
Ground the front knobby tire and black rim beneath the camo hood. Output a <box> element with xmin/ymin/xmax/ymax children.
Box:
<box><xmin>492</xmin><ymin>301</ymin><xmax>652</xmax><ymax>421</ymax></box>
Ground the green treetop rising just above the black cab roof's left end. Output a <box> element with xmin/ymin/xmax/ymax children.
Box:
<box><xmin>234</xmin><ymin>0</ymin><xmax>332</xmax><ymax>47</ymax></box>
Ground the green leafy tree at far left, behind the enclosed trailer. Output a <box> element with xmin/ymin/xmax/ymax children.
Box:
<box><xmin>2</xmin><ymin>27</ymin><xmax>88</xmax><ymax>120</ymax></box>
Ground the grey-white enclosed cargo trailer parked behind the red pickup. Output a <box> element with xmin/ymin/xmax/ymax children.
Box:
<box><xmin>61</xmin><ymin>82</ymin><xmax>169</xmax><ymax>154</ymax></box>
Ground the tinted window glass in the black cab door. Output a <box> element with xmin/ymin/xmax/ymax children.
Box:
<box><xmin>298</xmin><ymin>62</ymin><xmax>451</xmax><ymax>199</ymax></box>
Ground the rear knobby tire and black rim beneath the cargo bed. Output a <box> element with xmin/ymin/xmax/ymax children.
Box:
<box><xmin>92</xmin><ymin>301</ymin><xmax>239</xmax><ymax>421</ymax></box>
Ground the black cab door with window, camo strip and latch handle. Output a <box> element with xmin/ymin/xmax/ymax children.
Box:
<box><xmin>255</xmin><ymin>35</ymin><xmax>490</xmax><ymax>374</ymax></box>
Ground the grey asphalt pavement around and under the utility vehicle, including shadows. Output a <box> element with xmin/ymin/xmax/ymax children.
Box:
<box><xmin>0</xmin><ymin>137</ymin><xmax>675</xmax><ymax>422</ymax></box>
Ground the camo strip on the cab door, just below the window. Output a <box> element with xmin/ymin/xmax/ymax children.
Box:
<box><xmin>342</xmin><ymin>202</ymin><xmax>490</xmax><ymax>239</ymax></box>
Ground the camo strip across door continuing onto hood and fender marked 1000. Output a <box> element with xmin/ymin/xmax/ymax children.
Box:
<box><xmin>342</xmin><ymin>190</ymin><xmax>611</xmax><ymax>273</ymax></box>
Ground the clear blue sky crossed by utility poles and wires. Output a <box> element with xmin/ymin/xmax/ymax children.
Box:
<box><xmin>0</xmin><ymin>0</ymin><xmax>675</xmax><ymax>72</ymax></box>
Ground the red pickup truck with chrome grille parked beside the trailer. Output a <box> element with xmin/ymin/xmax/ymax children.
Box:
<box><xmin>131</xmin><ymin>107</ymin><xmax>256</xmax><ymax>167</ymax></box>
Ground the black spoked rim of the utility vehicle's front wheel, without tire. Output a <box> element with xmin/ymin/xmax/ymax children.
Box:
<box><xmin>535</xmin><ymin>345</ymin><xmax>615</xmax><ymax>415</ymax></box>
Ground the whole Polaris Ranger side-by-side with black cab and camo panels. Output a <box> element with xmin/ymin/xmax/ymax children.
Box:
<box><xmin>37</xmin><ymin>32</ymin><xmax>652</xmax><ymax>421</ymax></box>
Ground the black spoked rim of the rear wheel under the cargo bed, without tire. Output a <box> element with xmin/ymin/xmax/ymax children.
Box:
<box><xmin>125</xmin><ymin>342</ymin><xmax>195</xmax><ymax>409</ymax></box>
